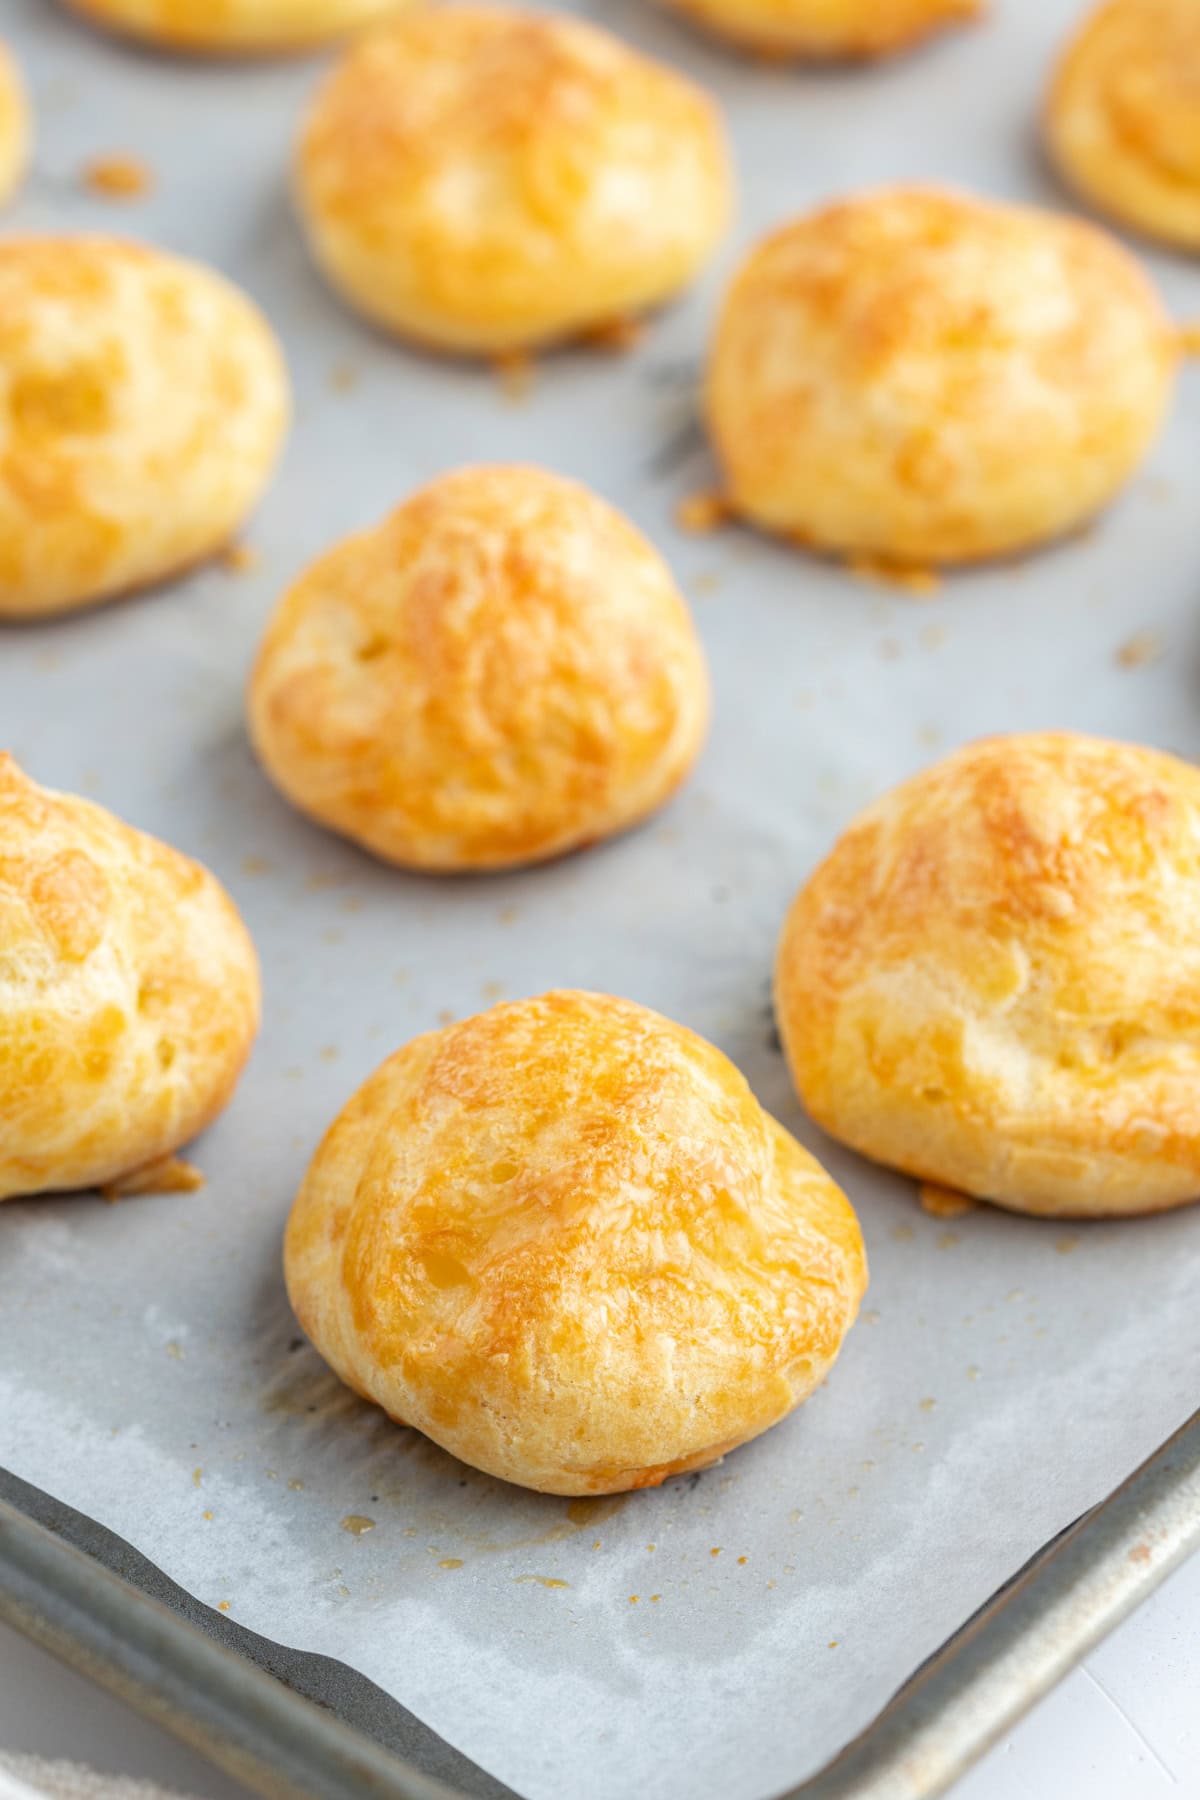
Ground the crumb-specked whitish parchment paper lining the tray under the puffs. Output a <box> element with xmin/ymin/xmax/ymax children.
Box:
<box><xmin>0</xmin><ymin>0</ymin><xmax>1200</xmax><ymax>1800</ymax></box>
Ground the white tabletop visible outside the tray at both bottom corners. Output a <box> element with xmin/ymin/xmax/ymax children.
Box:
<box><xmin>0</xmin><ymin>1557</ymin><xmax>1200</xmax><ymax>1800</ymax></box>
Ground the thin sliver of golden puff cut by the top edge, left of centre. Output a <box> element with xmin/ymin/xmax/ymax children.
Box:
<box><xmin>68</xmin><ymin>0</ymin><xmax>417</xmax><ymax>54</ymax></box>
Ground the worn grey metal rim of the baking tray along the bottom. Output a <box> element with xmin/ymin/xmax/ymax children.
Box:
<box><xmin>0</xmin><ymin>1411</ymin><xmax>1200</xmax><ymax>1800</ymax></box>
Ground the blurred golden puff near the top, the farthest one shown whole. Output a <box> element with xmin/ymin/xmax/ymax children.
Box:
<box><xmin>297</xmin><ymin>5</ymin><xmax>730</xmax><ymax>355</ymax></box>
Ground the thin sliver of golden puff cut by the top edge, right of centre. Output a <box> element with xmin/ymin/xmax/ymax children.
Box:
<box><xmin>666</xmin><ymin>0</ymin><xmax>984</xmax><ymax>58</ymax></box>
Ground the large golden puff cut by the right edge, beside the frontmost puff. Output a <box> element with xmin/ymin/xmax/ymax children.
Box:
<box><xmin>775</xmin><ymin>733</ymin><xmax>1200</xmax><ymax>1217</ymax></box>
